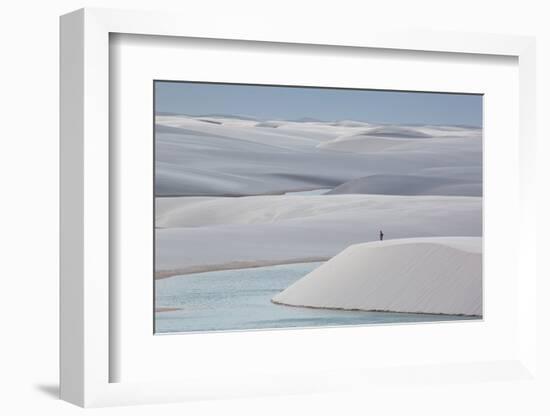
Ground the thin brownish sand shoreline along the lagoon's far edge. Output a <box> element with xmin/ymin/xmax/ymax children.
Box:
<box><xmin>154</xmin><ymin>256</ymin><xmax>331</xmax><ymax>280</ymax></box>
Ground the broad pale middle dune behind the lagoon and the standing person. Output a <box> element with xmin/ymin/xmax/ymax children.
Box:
<box><xmin>155</xmin><ymin>195</ymin><xmax>482</xmax><ymax>276</ymax></box>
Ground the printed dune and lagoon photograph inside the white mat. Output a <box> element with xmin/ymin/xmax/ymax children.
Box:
<box><xmin>153</xmin><ymin>81</ymin><xmax>483</xmax><ymax>333</ymax></box>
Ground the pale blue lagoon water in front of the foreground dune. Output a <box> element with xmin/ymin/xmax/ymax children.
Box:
<box><xmin>155</xmin><ymin>263</ymin><xmax>476</xmax><ymax>333</ymax></box>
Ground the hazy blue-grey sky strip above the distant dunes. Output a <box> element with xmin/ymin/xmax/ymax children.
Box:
<box><xmin>155</xmin><ymin>81</ymin><xmax>482</xmax><ymax>127</ymax></box>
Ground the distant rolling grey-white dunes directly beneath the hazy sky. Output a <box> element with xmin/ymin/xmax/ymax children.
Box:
<box><xmin>155</xmin><ymin>115</ymin><xmax>481</xmax><ymax>196</ymax></box>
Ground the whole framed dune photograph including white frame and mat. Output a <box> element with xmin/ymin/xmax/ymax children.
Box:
<box><xmin>61</xmin><ymin>9</ymin><xmax>536</xmax><ymax>406</ymax></box>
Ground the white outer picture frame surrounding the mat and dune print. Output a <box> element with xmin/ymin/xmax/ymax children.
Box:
<box><xmin>60</xmin><ymin>9</ymin><xmax>536</xmax><ymax>407</ymax></box>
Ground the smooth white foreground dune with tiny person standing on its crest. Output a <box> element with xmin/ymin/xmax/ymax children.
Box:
<box><xmin>273</xmin><ymin>237</ymin><xmax>482</xmax><ymax>316</ymax></box>
